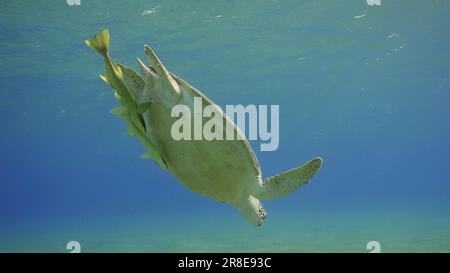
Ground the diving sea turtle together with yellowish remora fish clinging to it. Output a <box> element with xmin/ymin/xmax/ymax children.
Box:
<box><xmin>85</xmin><ymin>29</ymin><xmax>322</xmax><ymax>226</ymax></box>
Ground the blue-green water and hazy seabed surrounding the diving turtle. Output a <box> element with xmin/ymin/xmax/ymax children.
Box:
<box><xmin>0</xmin><ymin>0</ymin><xmax>450</xmax><ymax>252</ymax></box>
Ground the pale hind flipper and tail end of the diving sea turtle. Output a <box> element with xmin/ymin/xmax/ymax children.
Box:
<box><xmin>137</xmin><ymin>45</ymin><xmax>181</xmax><ymax>102</ymax></box>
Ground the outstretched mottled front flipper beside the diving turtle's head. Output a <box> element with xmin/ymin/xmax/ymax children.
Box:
<box><xmin>255</xmin><ymin>157</ymin><xmax>322</xmax><ymax>200</ymax></box>
